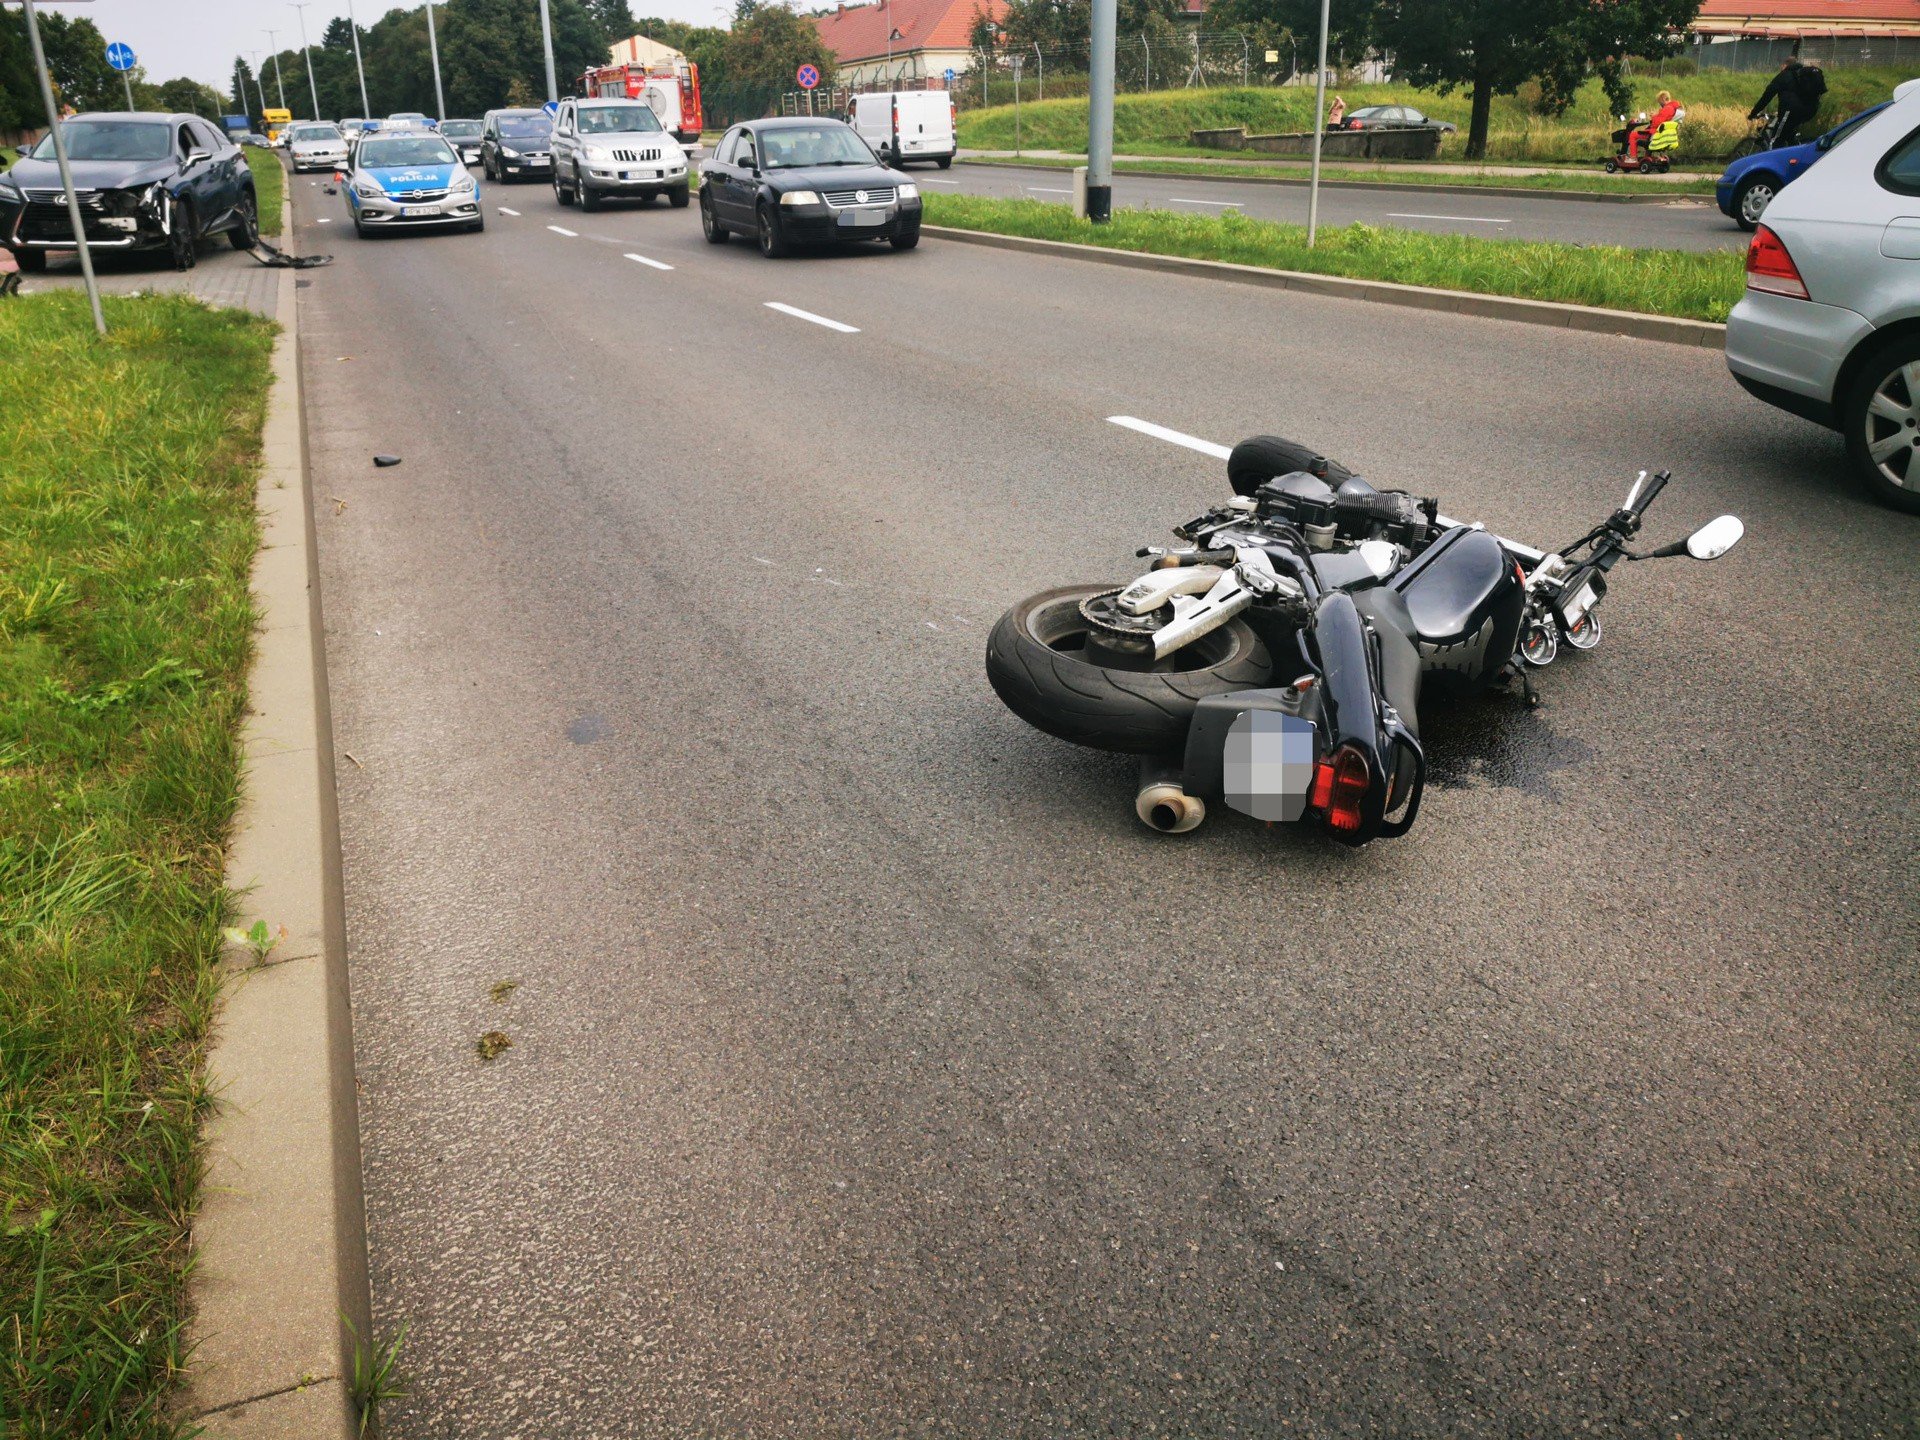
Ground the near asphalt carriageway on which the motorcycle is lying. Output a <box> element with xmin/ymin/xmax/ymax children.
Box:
<box><xmin>296</xmin><ymin>171</ymin><xmax>1920</xmax><ymax>1440</ymax></box>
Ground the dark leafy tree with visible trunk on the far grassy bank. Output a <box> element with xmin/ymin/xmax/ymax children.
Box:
<box><xmin>1379</xmin><ymin>0</ymin><xmax>1699</xmax><ymax>159</ymax></box>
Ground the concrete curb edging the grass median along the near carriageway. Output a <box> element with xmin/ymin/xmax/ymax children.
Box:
<box><xmin>920</xmin><ymin>225</ymin><xmax>1726</xmax><ymax>348</ymax></box>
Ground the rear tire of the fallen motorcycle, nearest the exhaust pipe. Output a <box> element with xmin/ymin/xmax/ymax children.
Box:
<box><xmin>987</xmin><ymin>586</ymin><xmax>1273</xmax><ymax>755</ymax></box>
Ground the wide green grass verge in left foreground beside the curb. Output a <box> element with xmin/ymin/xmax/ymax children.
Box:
<box><xmin>0</xmin><ymin>292</ymin><xmax>273</xmax><ymax>1440</ymax></box>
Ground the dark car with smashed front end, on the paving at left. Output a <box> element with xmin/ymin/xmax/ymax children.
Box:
<box><xmin>0</xmin><ymin>113</ymin><xmax>259</xmax><ymax>271</ymax></box>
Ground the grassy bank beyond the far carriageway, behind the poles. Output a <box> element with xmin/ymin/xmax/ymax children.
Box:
<box><xmin>960</xmin><ymin>67</ymin><xmax>1912</xmax><ymax>165</ymax></box>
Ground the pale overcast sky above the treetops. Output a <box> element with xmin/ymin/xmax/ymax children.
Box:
<box><xmin>58</xmin><ymin>0</ymin><xmax>733</xmax><ymax>90</ymax></box>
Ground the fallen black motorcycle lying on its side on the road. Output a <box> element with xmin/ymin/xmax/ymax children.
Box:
<box><xmin>987</xmin><ymin>436</ymin><xmax>1743</xmax><ymax>845</ymax></box>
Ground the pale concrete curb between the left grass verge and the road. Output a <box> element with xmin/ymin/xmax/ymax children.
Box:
<box><xmin>180</xmin><ymin>225</ymin><xmax>371</xmax><ymax>1440</ymax></box>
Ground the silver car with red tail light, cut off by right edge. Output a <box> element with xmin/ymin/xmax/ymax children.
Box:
<box><xmin>1726</xmin><ymin>83</ymin><xmax>1920</xmax><ymax>515</ymax></box>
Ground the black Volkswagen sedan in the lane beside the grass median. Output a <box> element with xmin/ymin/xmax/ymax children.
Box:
<box><xmin>701</xmin><ymin>119</ymin><xmax>920</xmax><ymax>255</ymax></box>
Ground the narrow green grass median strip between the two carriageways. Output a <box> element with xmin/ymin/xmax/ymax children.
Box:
<box><xmin>924</xmin><ymin>196</ymin><xmax>1745</xmax><ymax>321</ymax></box>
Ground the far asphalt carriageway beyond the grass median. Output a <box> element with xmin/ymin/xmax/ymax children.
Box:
<box><xmin>929</xmin><ymin>161</ymin><xmax>1747</xmax><ymax>250</ymax></box>
